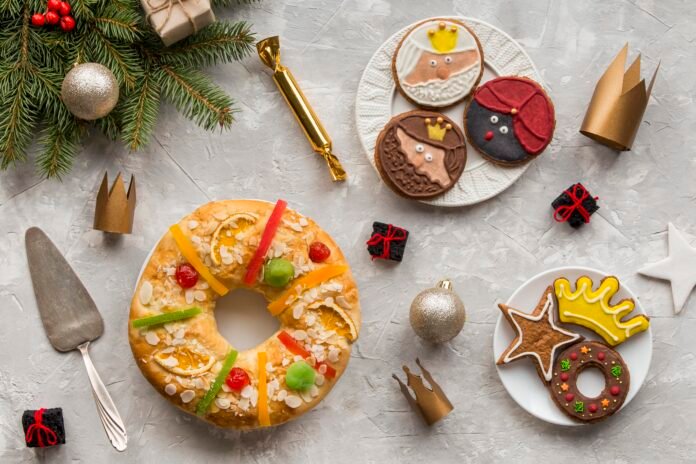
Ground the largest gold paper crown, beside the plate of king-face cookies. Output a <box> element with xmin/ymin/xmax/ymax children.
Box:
<box><xmin>580</xmin><ymin>44</ymin><xmax>660</xmax><ymax>151</ymax></box>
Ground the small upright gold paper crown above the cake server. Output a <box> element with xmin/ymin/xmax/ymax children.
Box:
<box><xmin>94</xmin><ymin>172</ymin><xmax>135</xmax><ymax>234</ymax></box>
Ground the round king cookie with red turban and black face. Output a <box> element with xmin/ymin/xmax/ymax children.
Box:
<box><xmin>464</xmin><ymin>76</ymin><xmax>556</xmax><ymax>166</ymax></box>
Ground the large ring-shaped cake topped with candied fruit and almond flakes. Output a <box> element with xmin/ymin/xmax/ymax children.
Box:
<box><xmin>128</xmin><ymin>200</ymin><xmax>360</xmax><ymax>429</ymax></box>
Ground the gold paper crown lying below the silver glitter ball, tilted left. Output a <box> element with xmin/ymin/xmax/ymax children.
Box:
<box><xmin>392</xmin><ymin>358</ymin><xmax>454</xmax><ymax>425</ymax></box>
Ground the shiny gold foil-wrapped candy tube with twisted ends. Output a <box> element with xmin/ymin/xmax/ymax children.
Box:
<box><xmin>256</xmin><ymin>36</ymin><xmax>346</xmax><ymax>181</ymax></box>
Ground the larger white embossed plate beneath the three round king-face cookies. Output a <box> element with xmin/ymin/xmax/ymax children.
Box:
<box><xmin>355</xmin><ymin>16</ymin><xmax>543</xmax><ymax>206</ymax></box>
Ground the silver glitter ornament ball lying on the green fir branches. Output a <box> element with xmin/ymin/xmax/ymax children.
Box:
<box><xmin>60</xmin><ymin>63</ymin><xmax>118</xmax><ymax>121</ymax></box>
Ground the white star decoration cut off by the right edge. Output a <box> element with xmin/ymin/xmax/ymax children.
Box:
<box><xmin>638</xmin><ymin>222</ymin><xmax>696</xmax><ymax>314</ymax></box>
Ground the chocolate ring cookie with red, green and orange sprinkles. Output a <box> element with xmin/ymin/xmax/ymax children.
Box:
<box><xmin>549</xmin><ymin>341</ymin><xmax>630</xmax><ymax>422</ymax></box>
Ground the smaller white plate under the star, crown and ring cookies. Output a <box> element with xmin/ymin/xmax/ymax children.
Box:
<box><xmin>493</xmin><ymin>267</ymin><xmax>652</xmax><ymax>425</ymax></box>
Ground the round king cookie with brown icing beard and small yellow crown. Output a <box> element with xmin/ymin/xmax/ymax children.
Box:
<box><xmin>375</xmin><ymin>110</ymin><xmax>466</xmax><ymax>199</ymax></box>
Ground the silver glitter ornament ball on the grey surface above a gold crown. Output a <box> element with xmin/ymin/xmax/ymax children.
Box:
<box><xmin>409</xmin><ymin>280</ymin><xmax>466</xmax><ymax>343</ymax></box>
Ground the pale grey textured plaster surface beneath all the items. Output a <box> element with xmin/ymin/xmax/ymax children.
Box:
<box><xmin>0</xmin><ymin>0</ymin><xmax>696</xmax><ymax>463</ymax></box>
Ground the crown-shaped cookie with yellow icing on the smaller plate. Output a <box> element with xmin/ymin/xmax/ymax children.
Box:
<box><xmin>553</xmin><ymin>276</ymin><xmax>650</xmax><ymax>346</ymax></box>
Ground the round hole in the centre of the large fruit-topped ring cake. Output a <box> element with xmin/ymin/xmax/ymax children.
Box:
<box><xmin>215</xmin><ymin>289</ymin><xmax>280</xmax><ymax>350</ymax></box>
